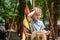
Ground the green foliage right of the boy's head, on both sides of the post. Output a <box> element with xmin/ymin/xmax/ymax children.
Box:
<box><xmin>35</xmin><ymin>0</ymin><xmax>60</xmax><ymax>20</ymax></box>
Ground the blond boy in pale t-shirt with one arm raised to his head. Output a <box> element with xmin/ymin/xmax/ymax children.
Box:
<box><xmin>28</xmin><ymin>8</ymin><xmax>50</xmax><ymax>40</ymax></box>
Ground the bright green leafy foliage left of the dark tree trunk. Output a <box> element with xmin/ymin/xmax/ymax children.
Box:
<box><xmin>0</xmin><ymin>0</ymin><xmax>18</xmax><ymax>22</ymax></box>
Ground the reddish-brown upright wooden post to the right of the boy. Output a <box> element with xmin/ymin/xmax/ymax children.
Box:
<box><xmin>49</xmin><ymin>2</ymin><xmax>55</xmax><ymax>40</ymax></box>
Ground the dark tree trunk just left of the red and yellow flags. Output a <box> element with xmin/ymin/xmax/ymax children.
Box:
<box><xmin>17</xmin><ymin>0</ymin><xmax>26</xmax><ymax>38</ymax></box>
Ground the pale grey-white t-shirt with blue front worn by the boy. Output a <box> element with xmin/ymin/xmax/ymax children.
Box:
<box><xmin>29</xmin><ymin>20</ymin><xmax>45</xmax><ymax>32</ymax></box>
